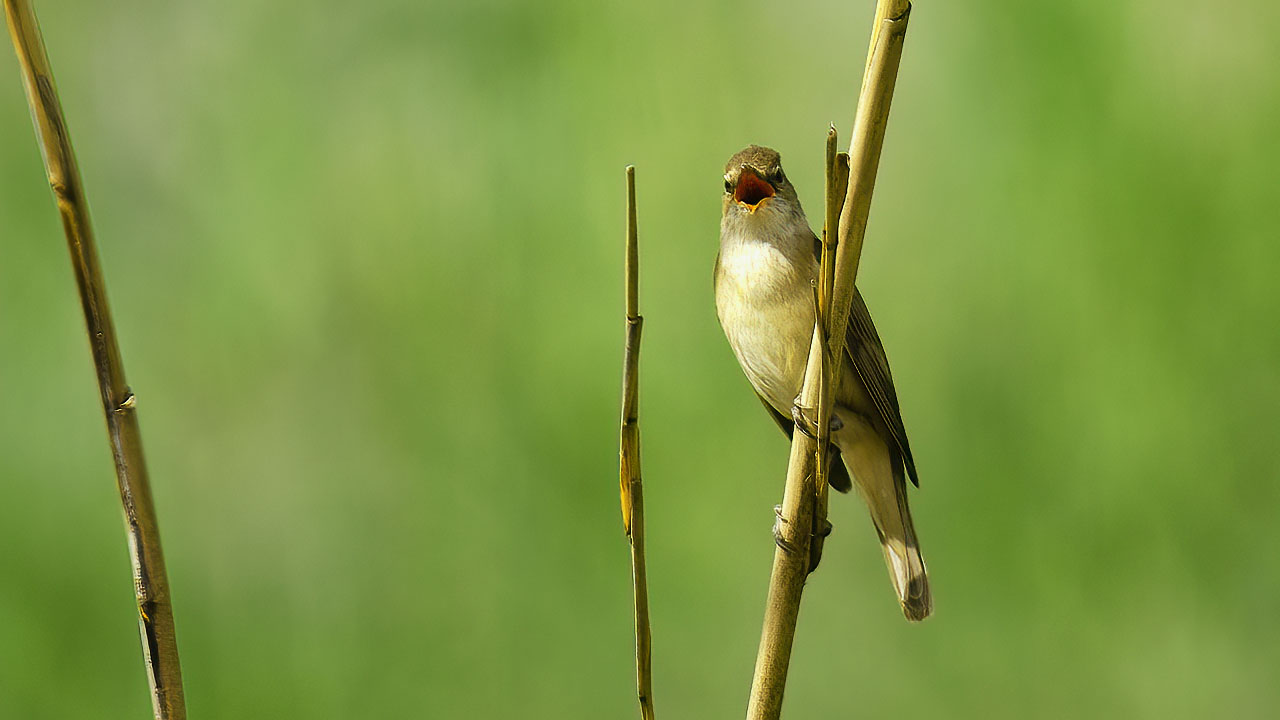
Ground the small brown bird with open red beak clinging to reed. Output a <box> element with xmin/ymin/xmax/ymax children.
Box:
<box><xmin>714</xmin><ymin>145</ymin><xmax>933</xmax><ymax>621</ymax></box>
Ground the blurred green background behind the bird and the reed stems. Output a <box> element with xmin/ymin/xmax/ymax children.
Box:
<box><xmin>0</xmin><ymin>0</ymin><xmax>1280</xmax><ymax>719</ymax></box>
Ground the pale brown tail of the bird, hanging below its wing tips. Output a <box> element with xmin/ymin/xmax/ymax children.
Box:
<box><xmin>844</xmin><ymin>420</ymin><xmax>933</xmax><ymax>621</ymax></box>
